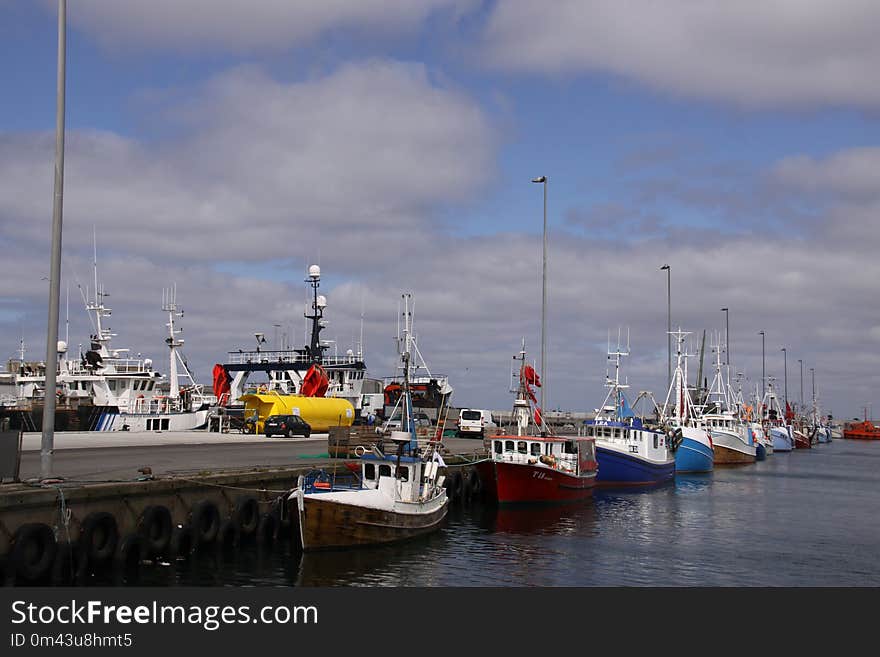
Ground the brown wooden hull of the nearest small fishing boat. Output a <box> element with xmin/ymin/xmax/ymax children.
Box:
<box><xmin>294</xmin><ymin>495</ymin><xmax>449</xmax><ymax>551</ymax></box>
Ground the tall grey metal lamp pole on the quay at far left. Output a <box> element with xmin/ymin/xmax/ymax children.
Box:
<box><xmin>40</xmin><ymin>0</ymin><xmax>67</xmax><ymax>478</ymax></box>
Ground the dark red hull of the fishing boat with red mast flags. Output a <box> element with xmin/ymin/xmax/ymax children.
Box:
<box><xmin>476</xmin><ymin>460</ymin><xmax>596</xmax><ymax>504</ymax></box>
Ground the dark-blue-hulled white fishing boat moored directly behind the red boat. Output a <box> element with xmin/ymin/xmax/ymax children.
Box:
<box><xmin>584</xmin><ymin>338</ymin><xmax>677</xmax><ymax>487</ymax></box>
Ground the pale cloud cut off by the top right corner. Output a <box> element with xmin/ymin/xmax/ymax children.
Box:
<box><xmin>484</xmin><ymin>0</ymin><xmax>880</xmax><ymax>107</ymax></box>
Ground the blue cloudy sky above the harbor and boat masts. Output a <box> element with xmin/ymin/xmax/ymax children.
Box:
<box><xmin>0</xmin><ymin>0</ymin><xmax>880</xmax><ymax>418</ymax></box>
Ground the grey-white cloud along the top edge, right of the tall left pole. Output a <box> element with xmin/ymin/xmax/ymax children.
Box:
<box><xmin>60</xmin><ymin>0</ymin><xmax>474</xmax><ymax>51</ymax></box>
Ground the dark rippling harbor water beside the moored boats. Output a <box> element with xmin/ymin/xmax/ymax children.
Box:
<box><xmin>139</xmin><ymin>440</ymin><xmax>880</xmax><ymax>586</ymax></box>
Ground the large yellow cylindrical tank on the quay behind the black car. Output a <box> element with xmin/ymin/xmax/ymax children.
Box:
<box><xmin>239</xmin><ymin>393</ymin><xmax>354</xmax><ymax>433</ymax></box>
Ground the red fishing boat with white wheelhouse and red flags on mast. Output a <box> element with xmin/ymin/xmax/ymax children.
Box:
<box><xmin>476</xmin><ymin>348</ymin><xmax>597</xmax><ymax>504</ymax></box>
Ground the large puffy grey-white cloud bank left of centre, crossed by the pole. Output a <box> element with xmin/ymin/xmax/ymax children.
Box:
<box><xmin>0</xmin><ymin>61</ymin><xmax>495</xmax><ymax>261</ymax></box>
